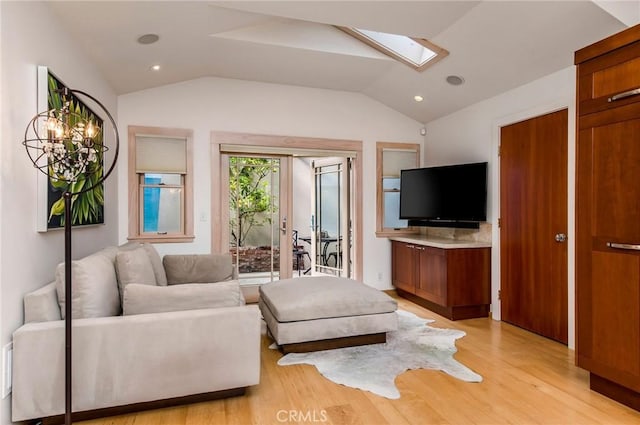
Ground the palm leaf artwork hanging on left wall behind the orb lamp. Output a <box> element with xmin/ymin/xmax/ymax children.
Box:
<box><xmin>37</xmin><ymin>66</ymin><xmax>104</xmax><ymax>232</ymax></box>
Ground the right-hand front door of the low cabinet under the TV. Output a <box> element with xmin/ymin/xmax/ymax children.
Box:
<box><xmin>416</xmin><ymin>246</ymin><xmax>448</xmax><ymax>306</ymax></box>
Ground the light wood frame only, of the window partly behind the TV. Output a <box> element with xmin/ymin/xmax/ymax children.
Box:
<box><xmin>376</xmin><ymin>142</ymin><xmax>421</xmax><ymax>238</ymax></box>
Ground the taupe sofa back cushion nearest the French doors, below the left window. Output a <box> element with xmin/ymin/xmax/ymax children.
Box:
<box><xmin>162</xmin><ymin>254</ymin><xmax>233</xmax><ymax>285</ymax></box>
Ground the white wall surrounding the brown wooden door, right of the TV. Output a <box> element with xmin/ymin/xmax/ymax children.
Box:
<box><xmin>425</xmin><ymin>67</ymin><xmax>576</xmax><ymax>348</ymax></box>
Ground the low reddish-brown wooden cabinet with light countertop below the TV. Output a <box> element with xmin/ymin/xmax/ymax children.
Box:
<box><xmin>391</xmin><ymin>237</ymin><xmax>491</xmax><ymax>320</ymax></box>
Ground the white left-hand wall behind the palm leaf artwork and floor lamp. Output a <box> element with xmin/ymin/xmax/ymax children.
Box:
<box><xmin>0</xmin><ymin>1</ymin><xmax>118</xmax><ymax>424</ymax></box>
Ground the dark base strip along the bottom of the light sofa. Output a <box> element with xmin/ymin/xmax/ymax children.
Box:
<box><xmin>37</xmin><ymin>387</ymin><xmax>246</xmax><ymax>425</ymax></box>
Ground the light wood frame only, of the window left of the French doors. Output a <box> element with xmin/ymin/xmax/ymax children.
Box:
<box><xmin>127</xmin><ymin>126</ymin><xmax>195</xmax><ymax>243</ymax></box>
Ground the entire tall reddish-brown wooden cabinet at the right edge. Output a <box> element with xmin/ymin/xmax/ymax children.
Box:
<box><xmin>575</xmin><ymin>26</ymin><xmax>640</xmax><ymax>410</ymax></box>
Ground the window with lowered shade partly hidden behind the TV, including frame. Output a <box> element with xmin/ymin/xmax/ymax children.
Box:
<box><xmin>376</xmin><ymin>142</ymin><xmax>420</xmax><ymax>236</ymax></box>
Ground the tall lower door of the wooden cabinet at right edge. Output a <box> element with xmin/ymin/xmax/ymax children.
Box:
<box><xmin>576</xmin><ymin>104</ymin><xmax>640</xmax><ymax>391</ymax></box>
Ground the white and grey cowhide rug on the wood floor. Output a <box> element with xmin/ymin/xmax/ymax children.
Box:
<box><xmin>272</xmin><ymin>310</ymin><xmax>482</xmax><ymax>399</ymax></box>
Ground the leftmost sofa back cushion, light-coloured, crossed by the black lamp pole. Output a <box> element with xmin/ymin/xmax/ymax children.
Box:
<box><xmin>56</xmin><ymin>250</ymin><xmax>121</xmax><ymax>319</ymax></box>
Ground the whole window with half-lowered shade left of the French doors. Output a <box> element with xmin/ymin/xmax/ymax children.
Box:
<box><xmin>129</xmin><ymin>127</ymin><xmax>193</xmax><ymax>242</ymax></box>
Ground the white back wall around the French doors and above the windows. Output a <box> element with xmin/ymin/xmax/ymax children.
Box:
<box><xmin>118</xmin><ymin>78</ymin><xmax>423</xmax><ymax>289</ymax></box>
